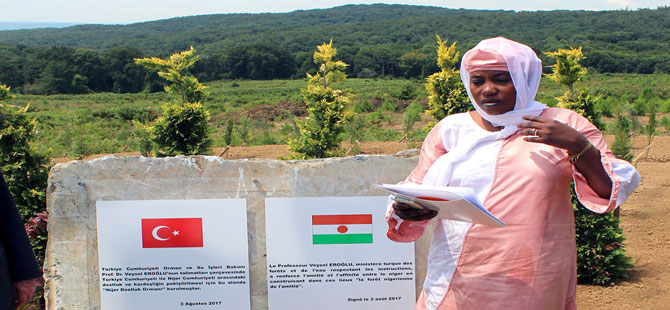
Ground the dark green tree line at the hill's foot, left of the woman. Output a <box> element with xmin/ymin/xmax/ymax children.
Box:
<box><xmin>0</xmin><ymin>43</ymin><xmax>437</xmax><ymax>95</ymax></box>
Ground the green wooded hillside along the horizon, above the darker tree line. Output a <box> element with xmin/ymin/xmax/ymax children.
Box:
<box><xmin>0</xmin><ymin>4</ymin><xmax>670</xmax><ymax>56</ymax></box>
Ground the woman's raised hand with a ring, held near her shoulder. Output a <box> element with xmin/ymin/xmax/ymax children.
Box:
<box><xmin>517</xmin><ymin>115</ymin><xmax>590</xmax><ymax>155</ymax></box>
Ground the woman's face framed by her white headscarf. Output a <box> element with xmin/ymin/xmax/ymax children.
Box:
<box><xmin>470</xmin><ymin>70</ymin><xmax>516</xmax><ymax>115</ymax></box>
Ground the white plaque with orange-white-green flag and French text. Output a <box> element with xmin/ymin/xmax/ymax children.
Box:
<box><xmin>265</xmin><ymin>196</ymin><xmax>415</xmax><ymax>310</ymax></box>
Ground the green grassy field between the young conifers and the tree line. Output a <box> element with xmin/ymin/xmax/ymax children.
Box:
<box><xmin>11</xmin><ymin>74</ymin><xmax>670</xmax><ymax>158</ymax></box>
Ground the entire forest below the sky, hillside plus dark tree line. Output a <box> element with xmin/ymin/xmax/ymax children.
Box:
<box><xmin>0</xmin><ymin>4</ymin><xmax>670</xmax><ymax>95</ymax></box>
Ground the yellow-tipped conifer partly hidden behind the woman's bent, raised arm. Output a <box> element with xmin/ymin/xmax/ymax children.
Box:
<box><xmin>545</xmin><ymin>48</ymin><xmax>633</xmax><ymax>285</ymax></box>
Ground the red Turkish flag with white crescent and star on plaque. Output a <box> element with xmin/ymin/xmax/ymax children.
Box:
<box><xmin>142</xmin><ymin>218</ymin><xmax>202</xmax><ymax>248</ymax></box>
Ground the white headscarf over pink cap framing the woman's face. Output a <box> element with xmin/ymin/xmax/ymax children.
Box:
<box><xmin>461</xmin><ymin>37</ymin><xmax>547</xmax><ymax>136</ymax></box>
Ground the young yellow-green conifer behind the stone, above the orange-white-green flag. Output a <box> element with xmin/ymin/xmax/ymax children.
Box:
<box><xmin>289</xmin><ymin>40</ymin><xmax>360</xmax><ymax>159</ymax></box>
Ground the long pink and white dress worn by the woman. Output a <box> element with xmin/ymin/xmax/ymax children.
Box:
<box><xmin>387</xmin><ymin>108</ymin><xmax>640</xmax><ymax>310</ymax></box>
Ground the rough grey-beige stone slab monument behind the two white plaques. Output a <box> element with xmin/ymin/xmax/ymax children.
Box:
<box><xmin>44</xmin><ymin>152</ymin><xmax>431</xmax><ymax>310</ymax></box>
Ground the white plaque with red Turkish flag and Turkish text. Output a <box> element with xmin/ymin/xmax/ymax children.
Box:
<box><xmin>96</xmin><ymin>199</ymin><xmax>250</xmax><ymax>310</ymax></box>
